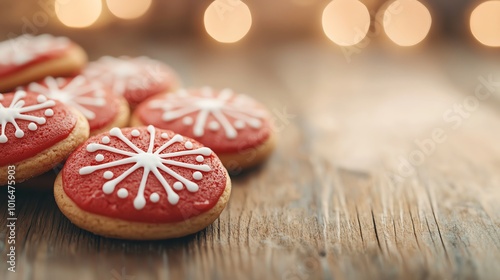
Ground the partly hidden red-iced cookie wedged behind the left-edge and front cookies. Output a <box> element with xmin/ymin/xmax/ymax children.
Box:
<box><xmin>28</xmin><ymin>76</ymin><xmax>130</xmax><ymax>135</ymax></box>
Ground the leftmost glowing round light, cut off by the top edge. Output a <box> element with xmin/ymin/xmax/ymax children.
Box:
<box><xmin>55</xmin><ymin>0</ymin><xmax>102</xmax><ymax>28</ymax></box>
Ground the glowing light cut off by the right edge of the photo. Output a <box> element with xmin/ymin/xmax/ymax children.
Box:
<box><xmin>470</xmin><ymin>1</ymin><xmax>500</xmax><ymax>47</ymax></box>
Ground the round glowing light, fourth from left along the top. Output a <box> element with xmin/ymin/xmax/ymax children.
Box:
<box><xmin>322</xmin><ymin>0</ymin><xmax>370</xmax><ymax>46</ymax></box>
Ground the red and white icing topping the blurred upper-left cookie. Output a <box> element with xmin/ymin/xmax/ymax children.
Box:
<box><xmin>0</xmin><ymin>35</ymin><xmax>75</xmax><ymax>79</ymax></box>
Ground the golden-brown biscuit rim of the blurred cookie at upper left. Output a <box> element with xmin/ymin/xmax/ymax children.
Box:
<box><xmin>0</xmin><ymin>45</ymin><xmax>87</xmax><ymax>92</ymax></box>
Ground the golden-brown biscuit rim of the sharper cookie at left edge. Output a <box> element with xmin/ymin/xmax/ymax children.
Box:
<box><xmin>0</xmin><ymin>109</ymin><xmax>89</xmax><ymax>186</ymax></box>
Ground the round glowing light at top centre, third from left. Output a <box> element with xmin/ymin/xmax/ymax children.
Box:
<box><xmin>204</xmin><ymin>0</ymin><xmax>252</xmax><ymax>43</ymax></box>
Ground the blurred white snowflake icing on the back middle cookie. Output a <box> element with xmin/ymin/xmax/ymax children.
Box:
<box><xmin>84</xmin><ymin>56</ymin><xmax>169</xmax><ymax>95</ymax></box>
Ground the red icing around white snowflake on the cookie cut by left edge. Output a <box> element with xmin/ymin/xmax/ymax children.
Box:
<box><xmin>0</xmin><ymin>92</ymin><xmax>77</xmax><ymax>166</ymax></box>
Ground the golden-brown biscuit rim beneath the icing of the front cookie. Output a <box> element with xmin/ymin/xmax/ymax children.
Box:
<box><xmin>54</xmin><ymin>173</ymin><xmax>231</xmax><ymax>240</ymax></box>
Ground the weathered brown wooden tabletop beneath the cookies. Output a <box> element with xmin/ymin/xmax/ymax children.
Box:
<box><xmin>0</xmin><ymin>41</ymin><xmax>500</xmax><ymax>280</ymax></box>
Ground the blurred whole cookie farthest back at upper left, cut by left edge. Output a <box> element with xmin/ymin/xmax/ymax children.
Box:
<box><xmin>0</xmin><ymin>34</ymin><xmax>87</xmax><ymax>92</ymax></box>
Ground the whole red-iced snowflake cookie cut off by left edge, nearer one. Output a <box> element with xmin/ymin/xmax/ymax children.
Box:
<box><xmin>0</xmin><ymin>90</ymin><xmax>89</xmax><ymax>185</ymax></box>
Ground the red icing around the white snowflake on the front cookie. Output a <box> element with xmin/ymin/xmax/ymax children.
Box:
<box><xmin>62</xmin><ymin>127</ymin><xmax>227</xmax><ymax>223</ymax></box>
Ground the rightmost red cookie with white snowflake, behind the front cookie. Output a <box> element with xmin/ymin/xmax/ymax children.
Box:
<box><xmin>131</xmin><ymin>87</ymin><xmax>274</xmax><ymax>171</ymax></box>
